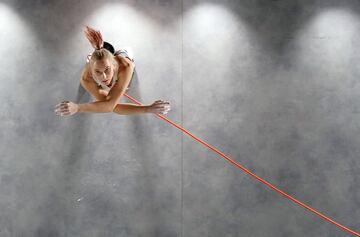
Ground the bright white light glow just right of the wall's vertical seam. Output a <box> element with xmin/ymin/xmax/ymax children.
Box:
<box><xmin>183</xmin><ymin>3</ymin><xmax>256</xmax><ymax>90</ymax></box>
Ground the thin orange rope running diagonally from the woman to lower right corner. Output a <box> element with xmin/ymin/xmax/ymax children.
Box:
<box><xmin>124</xmin><ymin>93</ymin><xmax>360</xmax><ymax>237</ymax></box>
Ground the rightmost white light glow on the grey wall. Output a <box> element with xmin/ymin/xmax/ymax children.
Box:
<box><xmin>295</xmin><ymin>8</ymin><xmax>359</xmax><ymax>74</ymax></box>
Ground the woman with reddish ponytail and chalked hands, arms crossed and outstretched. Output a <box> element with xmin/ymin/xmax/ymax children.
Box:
<box><xmin>54</xmin><ymin>26</ymin><xmax>170</xmax><ymax>116</ymax></box>
